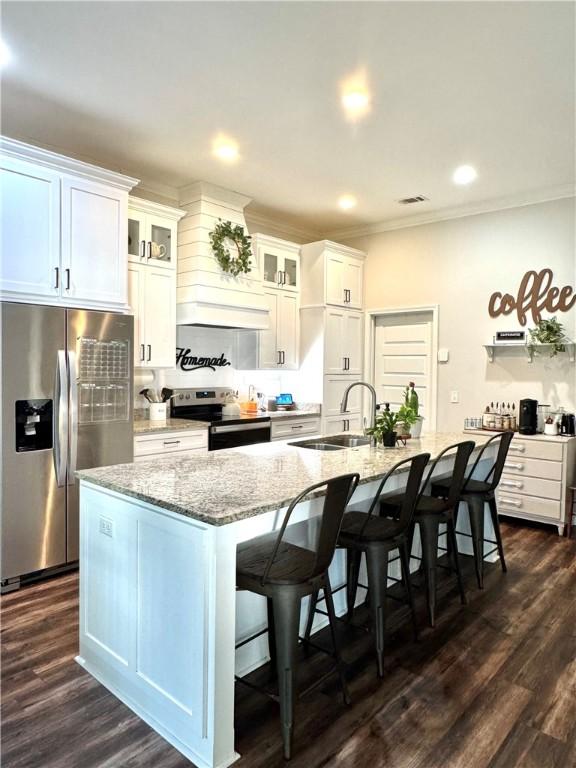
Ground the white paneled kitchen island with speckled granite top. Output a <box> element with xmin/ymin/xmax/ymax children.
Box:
<box><xmin>78</xmin><ymin>434</ymin><xmax>491</xmax><ymax>768</ymax></box>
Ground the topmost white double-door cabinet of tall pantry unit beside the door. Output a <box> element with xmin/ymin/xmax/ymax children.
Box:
<box><xmin>301</xmin><ymin>240</ymin><xmax>365</xmax><ymax>309</ymax></box>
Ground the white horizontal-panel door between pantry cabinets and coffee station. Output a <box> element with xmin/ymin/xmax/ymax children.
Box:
<box><xmin>374</xmin><ymin>312</ymin><xmax>432</xmax><ymax>428</ymax></box>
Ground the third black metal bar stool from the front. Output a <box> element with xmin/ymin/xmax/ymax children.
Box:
<box><xmin>380</xmin><ymin>440</ymin><xmax>475</xmax><ymax>627</ymax></box>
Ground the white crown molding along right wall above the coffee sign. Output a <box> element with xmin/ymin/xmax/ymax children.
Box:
<box><xmin>325</xmin><ymin>184</ymin><xmax>576</xmax><ymax>240</ymax></box>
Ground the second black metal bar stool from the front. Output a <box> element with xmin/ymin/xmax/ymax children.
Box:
<box><xmin>305</xmin><ymin>453</ymin><xmax>430</xmax><ymax>677</ymax></box>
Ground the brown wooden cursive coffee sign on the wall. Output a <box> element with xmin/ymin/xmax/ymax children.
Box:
<box><xmin>488</xmin><ymin>269</ymin><xmax>576</xmax><ymax>325</ymax></box>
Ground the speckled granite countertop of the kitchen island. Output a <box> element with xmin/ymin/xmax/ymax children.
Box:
<box><xmin>77</xmin><ymin>432</ymin><xmax>487</xmax><ymax>525</ymax></box>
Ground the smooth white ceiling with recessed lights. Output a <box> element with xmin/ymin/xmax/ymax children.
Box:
<box><xmin>1</xmin><ymin>0</ymin><xmax>576</xmax><ymax>232</ymax></box>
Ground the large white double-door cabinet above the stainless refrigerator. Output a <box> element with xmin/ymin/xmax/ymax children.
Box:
<box><xmin>0</xmin><ymin>138</ymin><xmax>138</xmax><ymax>311</ymax></box>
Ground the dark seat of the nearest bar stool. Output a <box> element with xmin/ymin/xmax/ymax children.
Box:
<box><xmin>236</xmin><ymin>533</ymin><xmax>316</xmax><ymax>595</ymax></box>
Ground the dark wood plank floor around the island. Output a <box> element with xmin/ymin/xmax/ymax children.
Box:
<box><xmin>2</xmin><ymin>523</ymin><xmax>576</xmax><ymax>768</ymax></box>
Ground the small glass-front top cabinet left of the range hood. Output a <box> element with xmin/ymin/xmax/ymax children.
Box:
<box><xmin>128</xmin><ymin>197</ymin><xmax>185</xmax><ymax>269</ymax></box>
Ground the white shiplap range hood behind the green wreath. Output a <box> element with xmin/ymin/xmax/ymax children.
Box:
<box><xmin>176</xmin><ymin>181</ymin><xmax>269</xmax><ymax>330</ymax></box>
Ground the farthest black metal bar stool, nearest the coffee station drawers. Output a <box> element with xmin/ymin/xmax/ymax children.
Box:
<box><xmin>432</xmin><ymin>430</ymin><xmax>514</xmax><ymax>589</ymax></box>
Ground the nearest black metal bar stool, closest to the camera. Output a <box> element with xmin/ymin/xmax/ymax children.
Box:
<box><xmin>236</xmin><ymin>474</ymin><xmax>360</xmax><ymax>760</ymax></box>
